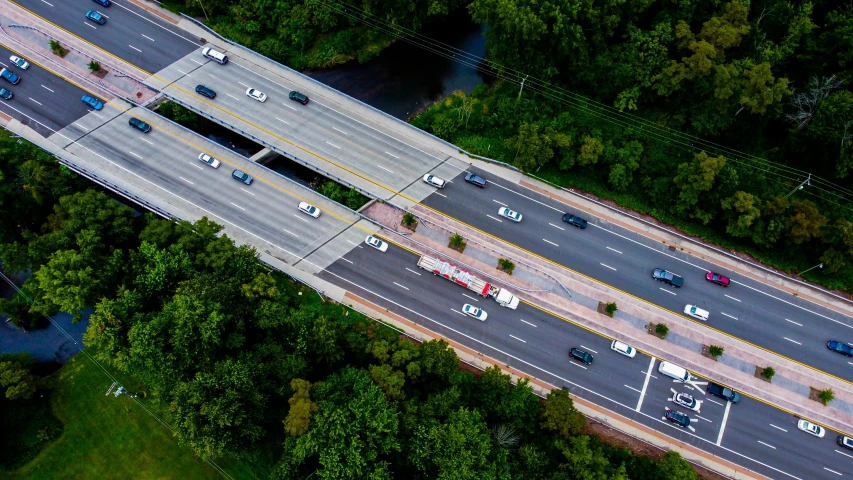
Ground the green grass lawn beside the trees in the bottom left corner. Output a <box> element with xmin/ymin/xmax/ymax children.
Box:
<box><xmin>0</xmin><ymin>354</ymin><xmax>223</xmax><ymax>480</ymax></box>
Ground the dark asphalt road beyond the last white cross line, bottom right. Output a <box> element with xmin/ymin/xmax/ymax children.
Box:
<box><xmin>721</xmin><ymin>399</ymin><xmax>853</xmax><ymax>480</ymax></box>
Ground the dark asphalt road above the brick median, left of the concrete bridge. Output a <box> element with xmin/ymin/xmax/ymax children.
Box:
<box><xmin>12</xmin><ymin>0</ymin><xmax>197</xmax><ymax>73</ymax></box>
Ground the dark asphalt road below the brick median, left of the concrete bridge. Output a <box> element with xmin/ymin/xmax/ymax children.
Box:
<box><xmin>0</xmin><ymin>45</ymin><xmax>88</xmax><ymax>133</ymax></box>
